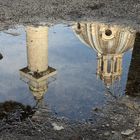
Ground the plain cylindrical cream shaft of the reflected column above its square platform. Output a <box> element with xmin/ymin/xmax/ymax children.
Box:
<box><xmin>26</xmin><ymin>26</ymin><xmax>48</xmax><ymax>73</ymax></box>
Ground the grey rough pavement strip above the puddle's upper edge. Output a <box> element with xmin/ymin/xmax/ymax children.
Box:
<box><xmin>0</xmin><ymin>0</ymin><xmax>140</xmax><ymax>29</ymax></box>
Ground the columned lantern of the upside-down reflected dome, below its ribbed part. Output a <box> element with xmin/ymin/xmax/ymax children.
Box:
<box><xmin>97</xmin><ymin>54</ymin><xmax>122</xmax><ymax>87</ymax></box>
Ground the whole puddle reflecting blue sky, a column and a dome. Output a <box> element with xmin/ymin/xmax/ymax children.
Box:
<box><xmin>0</xmin><ymin>23</ymin><xmax>135</xmax><ymax>120</ymax></box>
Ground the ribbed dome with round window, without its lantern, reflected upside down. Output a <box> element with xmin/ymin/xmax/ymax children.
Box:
<box><xmin>73</xmin><ymin>23</ymin><xmax>135</xmax><ymax>54</ymax></box>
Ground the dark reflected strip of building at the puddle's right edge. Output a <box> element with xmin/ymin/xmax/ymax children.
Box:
<box><xmin>126</xmin><ymin>33</ymin><xmax>140</xmax><ymax>96</ymax></box>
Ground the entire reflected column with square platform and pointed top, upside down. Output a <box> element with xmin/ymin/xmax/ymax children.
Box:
<box><xmin>20</xmin><ymin>26</ymin><xmax>56</xmax><ymax>105</ymax></box>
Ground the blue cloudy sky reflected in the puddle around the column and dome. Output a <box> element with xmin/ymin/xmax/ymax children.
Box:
<box><xmin>0</xmin><ymin>24</ymin><xmax>135</xmax><ymax>120</ymax></box>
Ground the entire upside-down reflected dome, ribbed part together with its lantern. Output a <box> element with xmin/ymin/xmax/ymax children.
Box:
<box><xmin>73</xmin><ymin>22</ymin><xmax>136</xmax><ymax>87</ymax></box>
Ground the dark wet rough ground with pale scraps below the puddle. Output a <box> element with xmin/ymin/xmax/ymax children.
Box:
<box><xmin>0</xmin><ymin>96</ymin><xmax>140</xmax><ymax>140</ymax></box>
